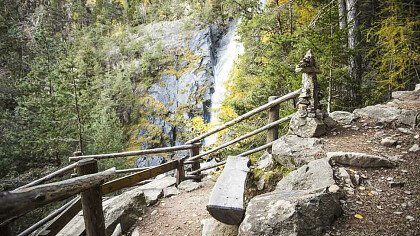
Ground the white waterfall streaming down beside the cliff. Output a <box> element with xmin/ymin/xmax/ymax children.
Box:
<box><xmin>204</xmin><ymin>20</ymin><xmax>244</xmax><ymax>145</ymax></box>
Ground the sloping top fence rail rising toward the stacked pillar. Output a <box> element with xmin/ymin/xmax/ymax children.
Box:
<box><xmin>186</xmin><ymin>89</ymin><xmax>301</xmax><ymax>144</ymax></box>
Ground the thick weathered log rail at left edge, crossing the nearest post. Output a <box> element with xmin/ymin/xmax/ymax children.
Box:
<box><xmin>0</xmin><ymin>168</ymin><xmax>115</xmax><ymax>225</ymax></box>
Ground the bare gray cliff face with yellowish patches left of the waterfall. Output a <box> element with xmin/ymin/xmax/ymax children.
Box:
<box><xmin>128</xmin><ymin>19</ymin><xmax>223</xmax><ymax>162</ymax></box>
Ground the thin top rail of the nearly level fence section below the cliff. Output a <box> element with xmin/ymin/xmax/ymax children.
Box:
<box><xmin>69</xmin><ymin>144</ymin><xmax>201</xmax><ymax>161</ymax></box>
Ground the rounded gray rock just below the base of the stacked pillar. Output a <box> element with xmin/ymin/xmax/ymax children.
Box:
<box><xmin>272</xmin><ymin>135</ymin><xmax>324</xmax><ymax>168</ymax></box>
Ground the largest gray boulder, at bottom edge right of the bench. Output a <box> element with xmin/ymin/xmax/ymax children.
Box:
<box><xmin>238</xmin><ymin>191</ymin><xmax>342</xmax><ymax>236</ymax></box>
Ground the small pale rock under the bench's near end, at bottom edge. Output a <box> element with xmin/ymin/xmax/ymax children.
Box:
<box><xmin>201</xmin><ymin>218</ymin><xmax>238</xmax><ymax>236</ymax></box>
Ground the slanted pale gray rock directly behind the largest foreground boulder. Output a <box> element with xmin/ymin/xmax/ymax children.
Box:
<box><xmin>276</xmin><ymin>158</ymin><xmax>335</xmax><ymax>191</ymax></box>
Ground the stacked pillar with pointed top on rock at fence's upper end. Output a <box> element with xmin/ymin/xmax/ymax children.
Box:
<box><xmin>289</xmin><ymin>50</ymin><xmax>327</xmax><ymax>137</ymax></box>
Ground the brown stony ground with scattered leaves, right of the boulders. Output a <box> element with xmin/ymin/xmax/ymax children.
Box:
<box><xmin>325</xmin><ymin>122</ymin><xmax>420</xmax><ymax>236</ymax></box>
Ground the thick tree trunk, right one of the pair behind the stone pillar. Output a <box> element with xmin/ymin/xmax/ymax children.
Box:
<box><xmin>346</xmin><ymin>0</ymin><xmax>362</xmax><ymax>107</ymax></box>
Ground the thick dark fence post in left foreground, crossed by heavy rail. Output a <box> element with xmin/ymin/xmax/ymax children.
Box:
<box><xmin>77</xmin><ymin>159</ymin><xmax>105</xmax><ymax>236</ymax></box>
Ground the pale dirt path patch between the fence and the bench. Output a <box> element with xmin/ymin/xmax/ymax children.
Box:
<box><xmin>136</xmin><ymin>179</ymin><xmax>214</xmax><ymax>236</ymax></box>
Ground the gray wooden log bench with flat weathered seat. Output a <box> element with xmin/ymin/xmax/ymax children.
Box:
<box><xmin>207</xmin><ymin>156</ymin><xmax>249</xmax><ymax>225</ymax></box>
